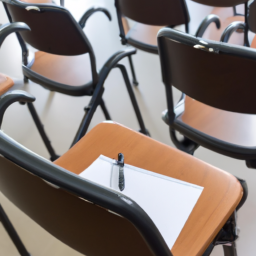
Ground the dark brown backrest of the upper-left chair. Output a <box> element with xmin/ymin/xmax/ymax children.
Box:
<box><xmin>2</xmin><ymin>0</ymin><xmax>98</xmax><ymax>82</ymax></box>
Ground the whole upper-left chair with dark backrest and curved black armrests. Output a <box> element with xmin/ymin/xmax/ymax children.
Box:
<box><xmin>3</xmin><ymin>0</ymin><xmax>148</xmax><ymax>157</ymax></box>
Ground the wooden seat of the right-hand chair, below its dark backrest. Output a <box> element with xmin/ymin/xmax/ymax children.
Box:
<box><xmin>178</xmin><ymin>96</ymin><xmax>256</xmax><ymax>147</ymax></box>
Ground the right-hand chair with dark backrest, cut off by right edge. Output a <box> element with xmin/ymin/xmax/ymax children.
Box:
<box><xmin>158</xmin><ymin>26</ymin><xmax>256</xmax><ymax>168</ymax></box>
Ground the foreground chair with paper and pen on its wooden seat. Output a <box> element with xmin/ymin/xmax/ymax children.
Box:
<box><xmin>0</xmin><ymin>121</ymin><xmax>247</xmax><ymax>256</ymax></box>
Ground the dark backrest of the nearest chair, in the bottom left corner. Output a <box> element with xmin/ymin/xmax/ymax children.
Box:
<box><xmin>0</xmin><ymin>131</ymin><xmax>172</xmax><ymax>256</ymax></box>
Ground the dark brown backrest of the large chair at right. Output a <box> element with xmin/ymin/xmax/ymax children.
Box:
<box><xmin>158</xmin><ymin>28</ymin><xmax>256</xmax><ymax>114</ymax></box>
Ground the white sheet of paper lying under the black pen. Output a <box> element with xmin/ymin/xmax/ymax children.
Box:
<box><xmin>80</xmin><ymin>155</ymin><xmax>204</xmax><ymax>250</ymax></box>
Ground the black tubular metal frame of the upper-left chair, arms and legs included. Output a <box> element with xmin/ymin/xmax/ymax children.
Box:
<box><xmin>3</xmin><ymin>0</ymin><xmax>149</xmax><ymax>156</ymax></box>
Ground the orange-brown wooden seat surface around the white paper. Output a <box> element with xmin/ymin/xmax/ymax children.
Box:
<box><xmin>55</xmin><ymin>122</ymin><xmax>243</xmax><ymax>256</ymax></box>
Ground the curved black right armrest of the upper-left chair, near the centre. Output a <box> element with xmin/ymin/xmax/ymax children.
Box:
<box><xmin>99</xmin><ymin>47</ymin><xmax>136</xmax><ymax>85</ymax></box>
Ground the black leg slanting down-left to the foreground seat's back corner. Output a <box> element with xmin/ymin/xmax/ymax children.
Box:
<box><xmin>71</xmin><ymin>87</ymin><xmax>104</xmax><ymax>147</ymax></box>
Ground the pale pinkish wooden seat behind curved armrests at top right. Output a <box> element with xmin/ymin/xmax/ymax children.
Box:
<box><xmin>203</xmin><ymin>7</ymin><xmax>244</xmax><ymax>45</ymax></box>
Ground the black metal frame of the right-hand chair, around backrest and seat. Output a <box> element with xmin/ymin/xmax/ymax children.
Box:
<box><xmin>158</xmin><ymin>27</ymin><xmax>256</xmax><ymax>168</ymax></box>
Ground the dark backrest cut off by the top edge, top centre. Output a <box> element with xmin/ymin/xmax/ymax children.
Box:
<box><xmin>116</xmin><ymin>0</ymin><xmax>189</xmax><ymax>26</ymax></box>
